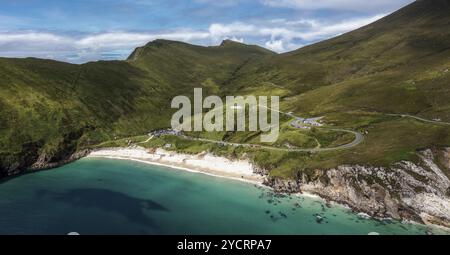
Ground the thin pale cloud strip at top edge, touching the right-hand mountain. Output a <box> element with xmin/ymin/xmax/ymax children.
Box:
<box><xmin>261</xmin><ymin>0</ymin><xmax>413</xmax><ymax>12</ymax></box>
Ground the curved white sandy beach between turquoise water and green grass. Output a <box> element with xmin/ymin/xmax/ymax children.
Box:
<box><xmin>88</xmin><ymin>146</ymin><xmax>264</xmax><ymax>184</ymax></box>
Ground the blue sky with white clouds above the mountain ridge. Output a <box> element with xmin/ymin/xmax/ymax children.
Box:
<box><xmin>0</xmin><ymin>0</ymin><xmax>413</xmax><ymax>63</ymax></box>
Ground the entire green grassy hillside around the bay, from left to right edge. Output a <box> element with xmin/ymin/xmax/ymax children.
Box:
<box><xmin>0</xmin><ymin>0</ymin><xmax>450</xmax><ymax>177</ymax></box>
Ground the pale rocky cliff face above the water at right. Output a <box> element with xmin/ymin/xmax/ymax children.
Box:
<box><xmin>266</xmin><ymin>149</ymin><xmax>450</xmax><ymax>227</ymax></box>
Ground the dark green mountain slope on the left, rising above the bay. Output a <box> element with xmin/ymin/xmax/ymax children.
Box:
<box><xmin>0</xmin><ymin>40</ymin><xmax>273</xmax><ymax>176</ymax></box>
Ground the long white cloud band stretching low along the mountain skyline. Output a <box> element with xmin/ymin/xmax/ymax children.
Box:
<box><xmin>0</xmin><ymin>12</ymin><xmax>383</xmax><ymax>62</ymax></box>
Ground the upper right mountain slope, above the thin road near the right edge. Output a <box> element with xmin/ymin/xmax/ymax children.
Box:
<box><xmin>229</xmin><ymin>0</ymin><xmax>450</xmax><ymax>114</ymax></box>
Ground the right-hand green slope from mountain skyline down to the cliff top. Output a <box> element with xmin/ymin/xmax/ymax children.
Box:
<box><xmin>207</xmin><ymin>0</ymin><xmax>450</xmax><ymax>176</ymax></box>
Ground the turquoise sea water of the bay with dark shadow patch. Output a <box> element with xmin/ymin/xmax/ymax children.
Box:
<box><xmin>0</xmin><ymin>158</ymin><xmax>443</xmax><ymax>235</ymax></box>
